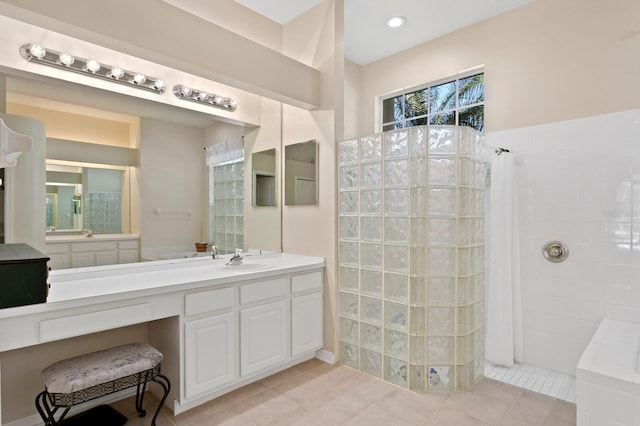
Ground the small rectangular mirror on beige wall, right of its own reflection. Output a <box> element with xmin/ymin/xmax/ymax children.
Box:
<box><xmin>284</xmin><ymin>141</ymin><xmax>318</xmax><ymax>206</ymax></box>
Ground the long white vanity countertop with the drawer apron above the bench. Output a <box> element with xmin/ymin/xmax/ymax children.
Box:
<box><xmin>0</xmin><ymin>253</ymin><xmax>325</xmax><ymax>351</ymax></box>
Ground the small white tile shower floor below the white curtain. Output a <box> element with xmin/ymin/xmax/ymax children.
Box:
<box><xmin>484</xmin><ymin>361</ymin><xmax>576</xmax><ymax>403</ymax></box>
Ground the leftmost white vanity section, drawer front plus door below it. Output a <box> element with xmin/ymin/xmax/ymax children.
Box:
<box><xmin>184</xmin><ymin>287</ymin><xmax>238</xmax><ymax>398</ymax></box>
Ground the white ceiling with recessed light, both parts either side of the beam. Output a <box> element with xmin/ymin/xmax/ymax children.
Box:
<box><xmin>232</xmin><ymin>0</ymin><xmax>534</xmax><ymax>65</ymax></box>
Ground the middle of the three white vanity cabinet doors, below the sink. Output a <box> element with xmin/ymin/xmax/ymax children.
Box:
<box><xmin>240</xmin><ymin>300</ymin><xmax>289</xmax><ymax>376</ymax></box>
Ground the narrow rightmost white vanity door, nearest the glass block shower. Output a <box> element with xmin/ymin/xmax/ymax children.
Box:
<box><xmin>291</xmin><ymin>292</ymin><xmax>323</xmax><ymax>356</ymax></box>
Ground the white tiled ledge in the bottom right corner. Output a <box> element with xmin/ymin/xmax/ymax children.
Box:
<box><xmin>576</xmin><ymin>319</ymin><xmax>640</xmax><ymax>426</ymax></box>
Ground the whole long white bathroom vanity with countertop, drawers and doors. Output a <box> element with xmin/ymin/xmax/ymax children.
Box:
<box><xmin>0</xmin><ymin>253</ymin><xmax>325</xmax><ymax>414</ymax></box>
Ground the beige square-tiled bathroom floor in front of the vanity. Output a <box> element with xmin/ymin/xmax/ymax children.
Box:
<box><xmin>113</xmin><ymin>359</ymin><xmax>576</xmax><ymax>426</ymax></box>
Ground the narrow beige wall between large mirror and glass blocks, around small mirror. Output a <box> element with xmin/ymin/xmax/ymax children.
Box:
<box><xmin>281</xmin><ymin>0</ymin><xmax>344</xmax><ymax>352</ymax></box>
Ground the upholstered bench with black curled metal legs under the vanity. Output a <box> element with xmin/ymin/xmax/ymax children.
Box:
<box><xmin>36</xmin><ymin>343</ymin><xmax>171</xmax><ymax>426</ymax></box>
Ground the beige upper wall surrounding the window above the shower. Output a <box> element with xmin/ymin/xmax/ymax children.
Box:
<box><xmin>356</xmin><ymin>0</ymin><xmax>640</xmax><ymax>137</ymax></box>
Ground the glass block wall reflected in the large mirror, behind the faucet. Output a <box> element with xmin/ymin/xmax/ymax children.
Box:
<box><xmin>209</xmin><ymin>158</ymin><xmax>244</xmax><ymax>254</ymax></box>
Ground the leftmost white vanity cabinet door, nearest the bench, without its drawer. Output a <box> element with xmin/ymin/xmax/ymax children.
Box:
<box><xmin>184</xmin><ymin>313</ymin><xmax>235</xmax><ymax>398</ymax></box>
